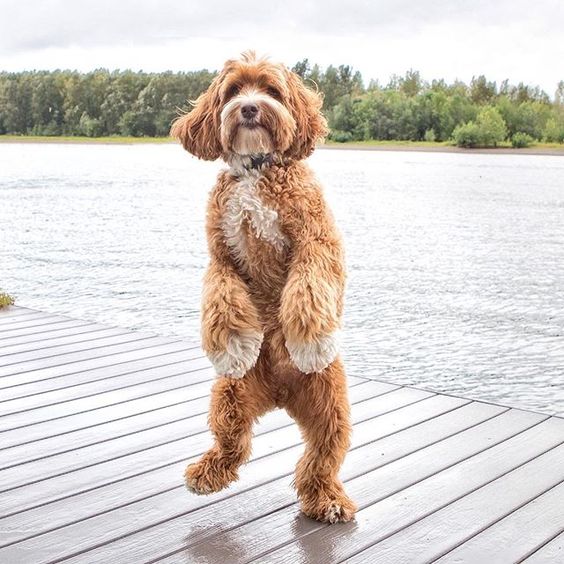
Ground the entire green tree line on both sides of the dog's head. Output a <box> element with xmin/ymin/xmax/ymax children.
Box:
<box><xmin>0</xmin><ymin>59</ymin><xmax>564</xmax><ymax>146</ymax></box>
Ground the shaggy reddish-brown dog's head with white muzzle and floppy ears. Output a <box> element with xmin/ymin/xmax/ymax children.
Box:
<box><xmin>171</xmin><ymin>52</ymin><xmax>327</xmax><ymax>161</ymax></box>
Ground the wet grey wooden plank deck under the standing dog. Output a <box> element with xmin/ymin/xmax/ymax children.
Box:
<box><xmin>0</xmin><ymin>307</ymin><xmax>564</xmax><ymax>564</ymax></box>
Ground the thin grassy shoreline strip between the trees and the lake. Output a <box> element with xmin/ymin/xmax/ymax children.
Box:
<box><xmin>0</xmin><ymin>135</ymin><xmax>564</xmax><ymax>156</ymax></box>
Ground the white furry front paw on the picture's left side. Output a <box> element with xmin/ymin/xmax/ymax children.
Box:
<box><xmin>207</xmin><ymin>331</ymin><xmax>263</xmax><ymax>378</ymax></box>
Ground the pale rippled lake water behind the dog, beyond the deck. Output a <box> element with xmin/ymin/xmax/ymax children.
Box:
<box><xmin>0</xmin><ymin>144</ymin><xmax>564</xmax><ymax>415</ymax></box>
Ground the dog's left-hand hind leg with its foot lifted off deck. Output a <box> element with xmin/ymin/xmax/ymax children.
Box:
<box><xmin>185</xmin><ymin>359</ymin><xmax>274</xmax><ymax>494</ymax></box>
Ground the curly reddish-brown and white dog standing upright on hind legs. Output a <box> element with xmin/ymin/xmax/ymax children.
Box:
<box><xmin>171</xmin><ymin>51</ymin><xmax>356</xmax><ymax>523</ymax></box>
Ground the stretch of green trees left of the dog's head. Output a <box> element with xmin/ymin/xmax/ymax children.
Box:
<box><xmin>0</xmin><ymin>69</ymin><xmax>215</xmax><ymax>137</ymax></box>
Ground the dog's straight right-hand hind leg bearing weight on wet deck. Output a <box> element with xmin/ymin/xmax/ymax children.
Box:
<box><xmin>286</xmin><ymin>359</ymin><xmax>356</xmax><ymax>523</ymax></box>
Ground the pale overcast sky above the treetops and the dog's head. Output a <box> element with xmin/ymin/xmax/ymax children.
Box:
<box><xmin>0</xmin><ymin>0</ymin><xmax>564</xmax><ymax>96</ymax></box>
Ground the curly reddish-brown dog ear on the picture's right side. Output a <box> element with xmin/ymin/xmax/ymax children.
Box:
<box><xmin>286</xmin><ymin>70</ymin><xmax>328</xmax><ymax>160</ymax></box>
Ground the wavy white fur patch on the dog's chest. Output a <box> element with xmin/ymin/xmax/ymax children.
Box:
<box><xmin>221</xmin><ymin>170</ymin><xmax>288</xmax><ymax>261</ymax></box>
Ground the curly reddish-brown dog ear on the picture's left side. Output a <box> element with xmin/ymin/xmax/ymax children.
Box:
<box><xmin>170</xmin><ymin>73</ymin><xmax>223</xmax><ymax>161</ymax></box>
